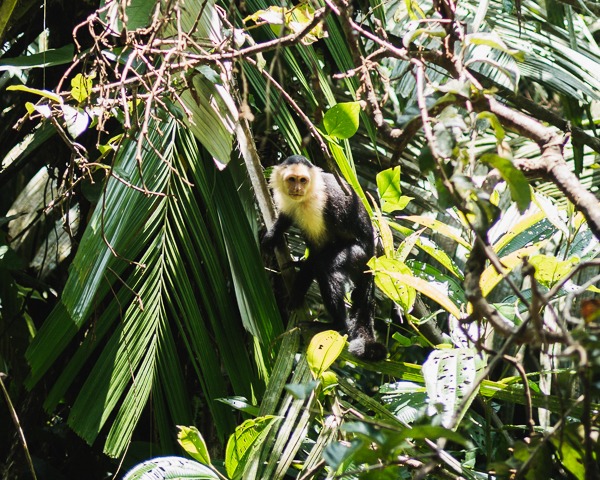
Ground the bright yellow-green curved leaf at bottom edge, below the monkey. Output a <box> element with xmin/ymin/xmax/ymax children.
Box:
<box><xmin>225</xmin><ymin>415</ymin><xmax>278</xmax><ymax>480</ymax></box>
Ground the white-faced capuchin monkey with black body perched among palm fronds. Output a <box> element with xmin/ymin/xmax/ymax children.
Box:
<box><xmin>262</xmin><ymin>155</ymin><xmax>387</xmax><ymax>361</ymax></box>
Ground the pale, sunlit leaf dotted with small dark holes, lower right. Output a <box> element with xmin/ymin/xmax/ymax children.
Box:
<box><xmin>423</xmin><ymin>348</ymin><xmax>485</xmax><ymax>429</ymax></box>
